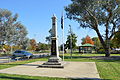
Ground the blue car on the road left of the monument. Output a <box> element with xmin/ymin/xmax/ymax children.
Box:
<box><xmin>12</xmin><ymin>50</ymin><xmax>33</xmax><ymax>58</ymax></box>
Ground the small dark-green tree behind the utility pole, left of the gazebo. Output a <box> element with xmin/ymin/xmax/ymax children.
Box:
<box><xmin>66</xmin><ymin>33</ymin><xmax>77</xmax><ymax>49</ymax></box>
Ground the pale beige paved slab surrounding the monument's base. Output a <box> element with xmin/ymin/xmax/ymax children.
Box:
<box><xmin>0</xmin><ymin>61</ymin><xmax>100</xmax><ymax>79</ymax></box>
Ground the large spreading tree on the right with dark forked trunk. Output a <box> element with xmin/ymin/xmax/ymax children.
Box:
<box><xmin>65</xmin><ymin>0</ymin><xmax>120</xmax><ymax>57</ymax></box>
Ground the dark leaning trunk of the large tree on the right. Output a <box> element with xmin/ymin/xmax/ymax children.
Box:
<box><xmin>95</xmin><ymin>29</ymin><xmax>110</xmax><ymax>57</ymax></box>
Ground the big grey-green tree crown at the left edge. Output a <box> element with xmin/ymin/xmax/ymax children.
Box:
<box><xmin>0</xmin><ymin>9</ymin><xmax>27</xmax><ymax>46</ymax></box>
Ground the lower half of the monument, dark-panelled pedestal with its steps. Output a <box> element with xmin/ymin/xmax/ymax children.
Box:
<box><xmin>39</xmin><ymin>37</ymin><xmax>64</xmax><ymax>68</ymax></box>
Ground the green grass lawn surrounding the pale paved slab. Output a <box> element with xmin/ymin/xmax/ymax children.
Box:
<box><xmin>0</xmin><ymin>53</ymin><xmax>120</xmax><ymax>80</ymax></box>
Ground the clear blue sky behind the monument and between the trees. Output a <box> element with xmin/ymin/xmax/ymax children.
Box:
<box><xmin>0</xmin><ymin>0</ymin><xmax>97</xmax><ymax>45</ymax></box>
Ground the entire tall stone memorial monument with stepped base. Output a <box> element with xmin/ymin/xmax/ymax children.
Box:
<box><xmin>39</xmin><ymin>15</ymin><xmax>64</xmax><ymax>68</ymax></box>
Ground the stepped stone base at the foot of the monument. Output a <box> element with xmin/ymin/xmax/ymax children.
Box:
<box><xmin>38</xmin><ymin>57</ymin><xmax>64</xmax><ymax>68</ymax></box>
